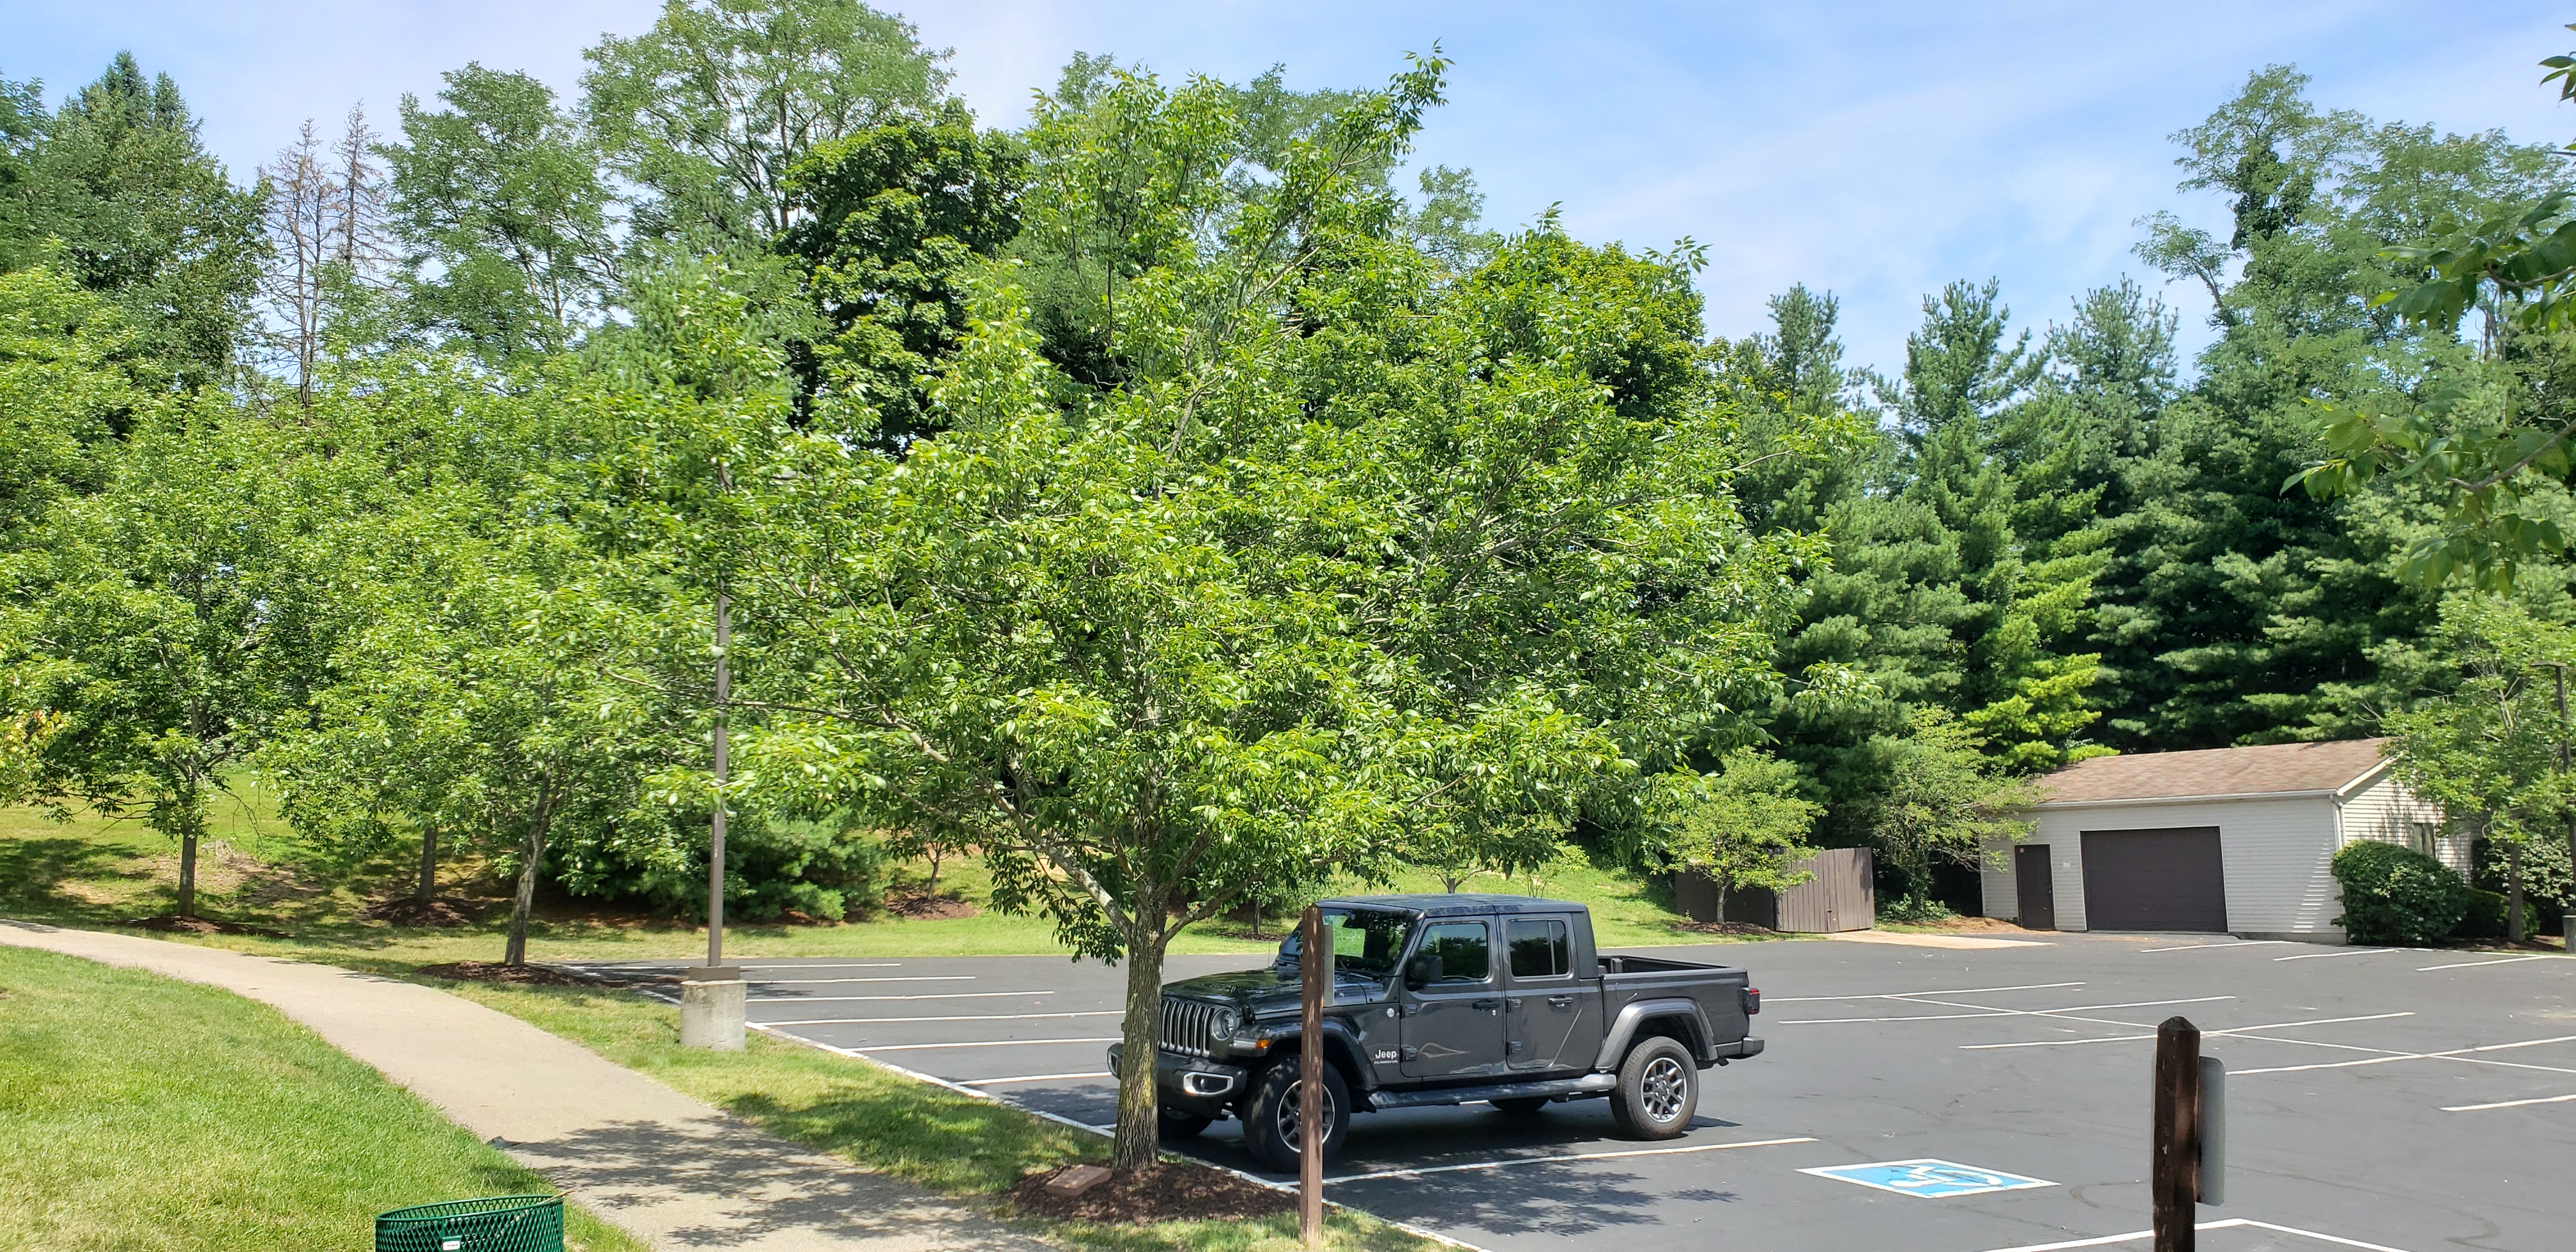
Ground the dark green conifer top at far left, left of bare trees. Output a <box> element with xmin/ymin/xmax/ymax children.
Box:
<box><xmin>0</xmin><ymin>54</ymin><xmax>265</xmax><ymax>384</ymax></box>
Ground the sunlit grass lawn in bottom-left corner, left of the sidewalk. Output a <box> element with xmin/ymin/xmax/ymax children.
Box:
<box><xmin>0</xmin><ymin>948</ymin><xmax>644</xmax><ymax>1252</ymax></box>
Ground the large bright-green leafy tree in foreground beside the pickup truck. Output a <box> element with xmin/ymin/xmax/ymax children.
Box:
<box><xmin>680</xmin><ymin>62</ymin><xmax>1813</xmax><ymax>1170</ymax></box>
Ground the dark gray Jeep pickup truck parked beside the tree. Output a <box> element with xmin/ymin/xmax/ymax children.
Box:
<box><xmin>1110</xmin><ymin>894</ymin><xmax>1762</xmax><ymax>1170</ymax></box>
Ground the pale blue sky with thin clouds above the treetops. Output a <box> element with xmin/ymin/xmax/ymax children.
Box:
<box><xmin>0</xmin><ymin>0</ymin><xmax>2576</xmax><ymax>369</ymax></box>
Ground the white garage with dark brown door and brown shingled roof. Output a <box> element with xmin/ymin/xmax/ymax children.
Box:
<box><xmin>1986</xmin><ymin>739</ymin><xmax>2468</xmax><ymax>943</ymax></box>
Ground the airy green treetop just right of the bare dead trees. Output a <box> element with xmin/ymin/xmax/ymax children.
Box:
<box><xmin>379</xmin><ymin>65</ymin><xmax>616</xmax><ymax>366</ymax></box>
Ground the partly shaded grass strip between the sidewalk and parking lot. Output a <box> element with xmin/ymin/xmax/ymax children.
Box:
<box><xmin>417</xmin><ymin>979</ymin><xmax>1438</xmax><ymax>1252</ymax></box>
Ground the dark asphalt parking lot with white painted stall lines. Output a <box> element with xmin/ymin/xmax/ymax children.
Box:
<box><xmin>574</xmin><ymin>935</ymin><xmax>2576</xmax><ymax>1252</ymax></box>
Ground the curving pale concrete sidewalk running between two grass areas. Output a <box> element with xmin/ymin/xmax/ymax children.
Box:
<box><xmin>0</xmin><ymin>922</ymin><xmax>1046</xmax><ymax>1252</ymax></box>
